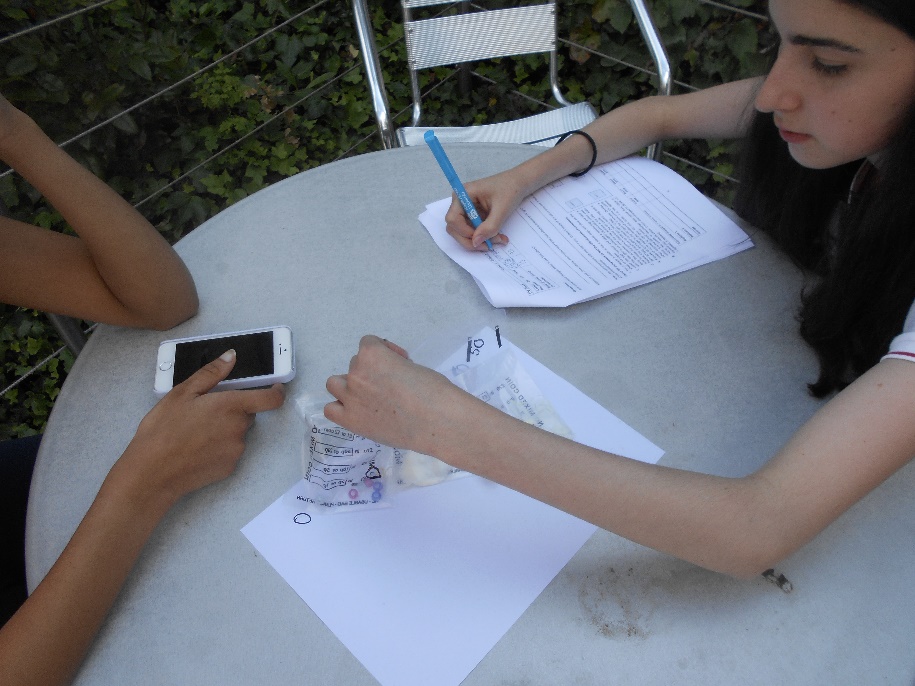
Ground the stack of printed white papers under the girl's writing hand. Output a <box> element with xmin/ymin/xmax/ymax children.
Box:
<box><xmin>419</xmin><ymin>157</ymin><xmax>753</xmax><ymax>307</ymax></box>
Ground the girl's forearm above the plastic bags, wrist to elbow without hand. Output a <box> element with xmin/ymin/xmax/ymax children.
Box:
<box><xmin>417</xmin><ymin>396</ymin><xmax>776</xmax><ymax>577</ymax></box>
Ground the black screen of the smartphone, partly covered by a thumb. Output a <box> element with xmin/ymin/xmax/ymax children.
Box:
<box><xmin>172</xmin><ymin>331</ymin><xmax>273</xmax><ymax>386</ymax></box>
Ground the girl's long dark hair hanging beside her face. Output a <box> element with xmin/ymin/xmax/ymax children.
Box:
<box><xmin>734</xmin><ymin>0</ymin><xmax>915</xmax><ymax>397</ymax></box>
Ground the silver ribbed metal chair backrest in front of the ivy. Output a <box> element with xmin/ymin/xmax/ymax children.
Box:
<box><xmin>401</xmin><ymin>0</ymin><xmax>571</xmax><ymax>126</ymax></box>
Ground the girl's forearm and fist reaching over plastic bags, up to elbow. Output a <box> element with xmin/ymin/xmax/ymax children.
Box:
<box><xmin>324</xmin><ymin>336</ymin><xmax>776</xmax><ymax>576</ymax></box>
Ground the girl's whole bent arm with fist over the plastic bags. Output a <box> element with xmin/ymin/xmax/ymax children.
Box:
<box><xmin>325</xmin><ymin>337</ymin><xmax>915</xmax><ymax>576</ymax></box>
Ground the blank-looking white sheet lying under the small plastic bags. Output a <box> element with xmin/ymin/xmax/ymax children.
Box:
<box><xmin>242</xmin><ymin>344</ymin><xmax>663</xmax><ymax>686</ymax></box>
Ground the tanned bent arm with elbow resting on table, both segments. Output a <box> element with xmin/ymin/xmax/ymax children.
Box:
<box><xmin>0</xmin><ymin>96</ymin><xmax>198</xmax><ymax>329</ymax></box>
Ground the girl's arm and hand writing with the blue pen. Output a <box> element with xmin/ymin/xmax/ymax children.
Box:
<box><xmin>446</xmin><ymin>78</ymin><xmax>761</xmax><ymax>250</ymax></box>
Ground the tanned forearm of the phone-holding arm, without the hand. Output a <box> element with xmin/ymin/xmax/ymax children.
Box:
<box><xmin>0</xmin><ymin>456</ymin><xmax>175</xmax><ymax>686</ymax></box>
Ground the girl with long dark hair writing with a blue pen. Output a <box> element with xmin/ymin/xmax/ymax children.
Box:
<box><xmin>325</xmin><ymin>0</ymin><xmax>915</xmax><ymax>576</ymax></box>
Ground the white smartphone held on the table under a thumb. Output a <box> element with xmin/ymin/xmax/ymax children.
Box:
<box><xmin>155</xmin><ymin>326</ymin><xmax>295</xmax><ymax>395</ymax></box>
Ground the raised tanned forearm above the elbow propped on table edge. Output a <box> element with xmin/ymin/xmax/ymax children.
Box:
<box><xmin>0</xmin><ymin>113</ymin><xmax>198</xmax><ymax>329</ymax></box>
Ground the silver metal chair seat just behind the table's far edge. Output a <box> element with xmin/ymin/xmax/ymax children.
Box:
<box><xmin>397</xmin><ymin>102</ymin><xmax>597</xmax><ymax>148</ymax></box>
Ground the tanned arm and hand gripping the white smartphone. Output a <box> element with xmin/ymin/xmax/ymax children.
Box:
<box><xmin>0</xmin><ymin>358</ymin><xmax>283</xmax><ymax>686</ymax></box>
